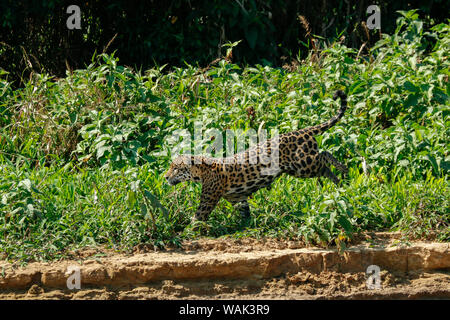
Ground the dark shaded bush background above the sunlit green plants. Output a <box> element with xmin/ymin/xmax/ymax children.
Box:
<box><xmin>0</xmin><ymin>0</ymin><xmax>450</xmax><ymax>85</ymax></box>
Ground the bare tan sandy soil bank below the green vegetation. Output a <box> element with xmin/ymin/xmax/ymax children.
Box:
<box><xmin>0</xmin><ymin>233</ymin><xmax>450</xmax><ymax>299</ymax></box>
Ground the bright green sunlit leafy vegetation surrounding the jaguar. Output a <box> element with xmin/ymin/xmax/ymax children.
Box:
<box><xmin>0</xmin><ymin>11</ymin><xmax>450</xmax><ymax>260</ymax></box>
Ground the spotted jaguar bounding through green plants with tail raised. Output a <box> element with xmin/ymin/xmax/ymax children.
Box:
<box><xmin>165</xmin><ymin>90</ymin><xmax>347</xmax><ymax>220</ymax></box>
